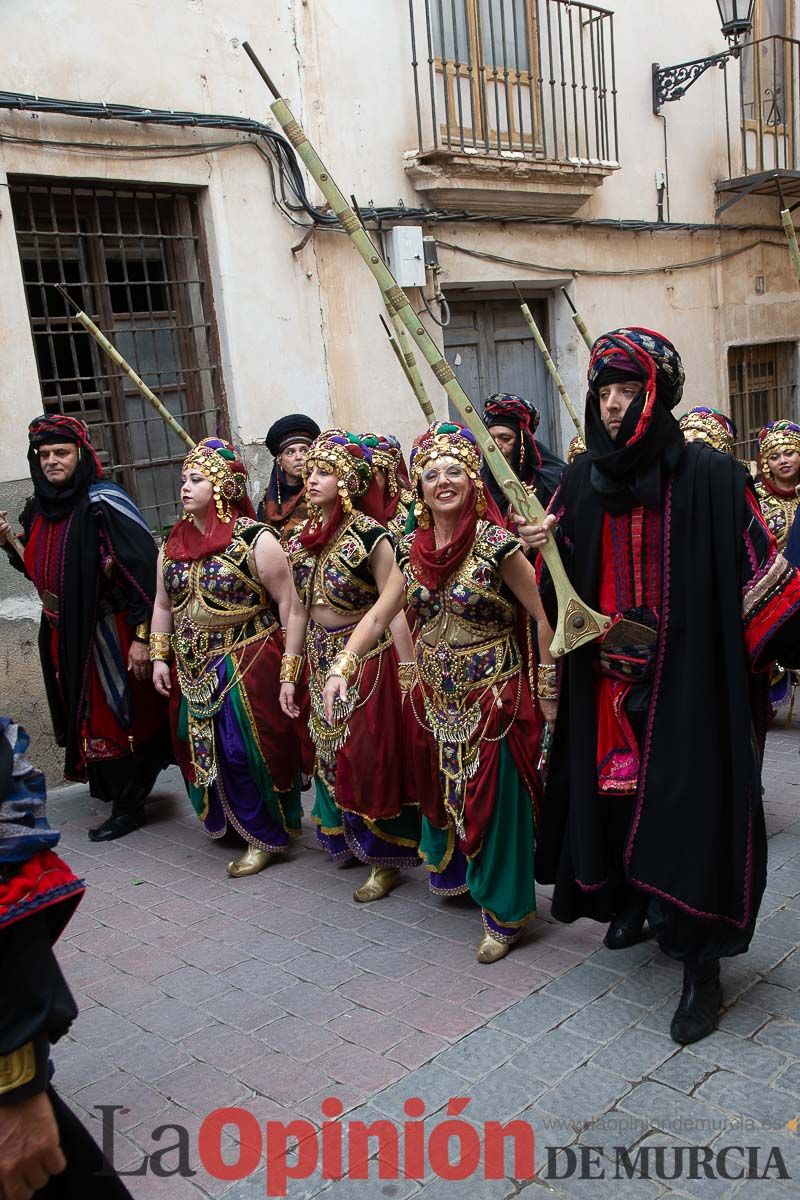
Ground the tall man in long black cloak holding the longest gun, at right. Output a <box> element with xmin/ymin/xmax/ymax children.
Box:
<box><xmin>519</xmin><ymin>328</ymin><xmax>800</xmax><ymax>1043</ymax></box>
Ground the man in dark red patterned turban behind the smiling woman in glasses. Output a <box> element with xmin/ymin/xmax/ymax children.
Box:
<box><xmin>483</xmin><ymin>391</ymin><xmax>566</xmax><ymax>516</ymax></box>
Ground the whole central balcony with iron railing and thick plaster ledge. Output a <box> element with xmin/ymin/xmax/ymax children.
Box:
<box><xmin>405</xmin><ymin>0</ymin><xmax>619</xmax><ymax>217</ymax></box>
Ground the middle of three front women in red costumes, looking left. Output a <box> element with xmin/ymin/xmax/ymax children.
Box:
<box><xmin>281</xmin><ymin>430</ymin><xmax>419</xmax><ymax>904</ymax></box>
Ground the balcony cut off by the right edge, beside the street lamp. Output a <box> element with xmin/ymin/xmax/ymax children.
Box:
<box><xmin>716</xmin><ymin>35</ymin><xmax>800</xmax><ymax>216</ymax></box>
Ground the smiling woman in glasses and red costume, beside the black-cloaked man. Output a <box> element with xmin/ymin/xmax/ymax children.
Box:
<box><xmin>325</xmin><ymin>421</ymin><xmax>555</xmax><ymax>962</ymax></box>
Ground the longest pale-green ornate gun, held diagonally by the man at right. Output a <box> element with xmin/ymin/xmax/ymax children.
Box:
<box><xmin>242</xmin><ymin>42</ymin><xmax>610</xmax><ymax>656</ymax></box>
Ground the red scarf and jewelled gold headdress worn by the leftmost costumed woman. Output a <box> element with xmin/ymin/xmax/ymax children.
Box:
<box><xmin>164</xmin><ymin>438</ymin><xmax>255</xmax><ymax>563</ymax></box>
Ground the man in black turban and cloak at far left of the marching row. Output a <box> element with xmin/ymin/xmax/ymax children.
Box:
<box><xmin>0</xmin><ymin>414</ymin><xmax>172</xmax><ymax>841</ymax></box>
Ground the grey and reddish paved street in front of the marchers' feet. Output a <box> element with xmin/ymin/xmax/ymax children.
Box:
<box><xmin>50</xmin><ymin>728</ymin><xmax>800</xmax><ymax>1200</ymax></box>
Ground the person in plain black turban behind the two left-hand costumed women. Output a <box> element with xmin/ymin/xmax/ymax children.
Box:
<box><xmin>257</xmin><ymin>413</ymin><xmax>319</xmax><ymax>547</ymax></box>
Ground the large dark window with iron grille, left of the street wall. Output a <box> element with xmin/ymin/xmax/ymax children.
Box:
<box><xmin>10</xmin><ymin>176</ymin><xmax>228</xmax><ymax>530</ymax></box>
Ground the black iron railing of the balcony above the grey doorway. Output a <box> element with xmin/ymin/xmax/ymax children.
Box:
<box><xmin>409</xmin><ymin>0</ymin><xmax>619</xmax><ymax>169</ymax></box>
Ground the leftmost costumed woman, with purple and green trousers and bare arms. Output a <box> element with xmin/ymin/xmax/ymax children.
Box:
<box><xmin>150</xmin><ymin>438</ymin><xmax>301</xmax><ymax>877</ymax></box>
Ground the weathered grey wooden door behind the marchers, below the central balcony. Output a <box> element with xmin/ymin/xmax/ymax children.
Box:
<box><xmin>445</xmin><ymin>300</ymin><xmax>560</xmax><ymax>454</ymax></box>
